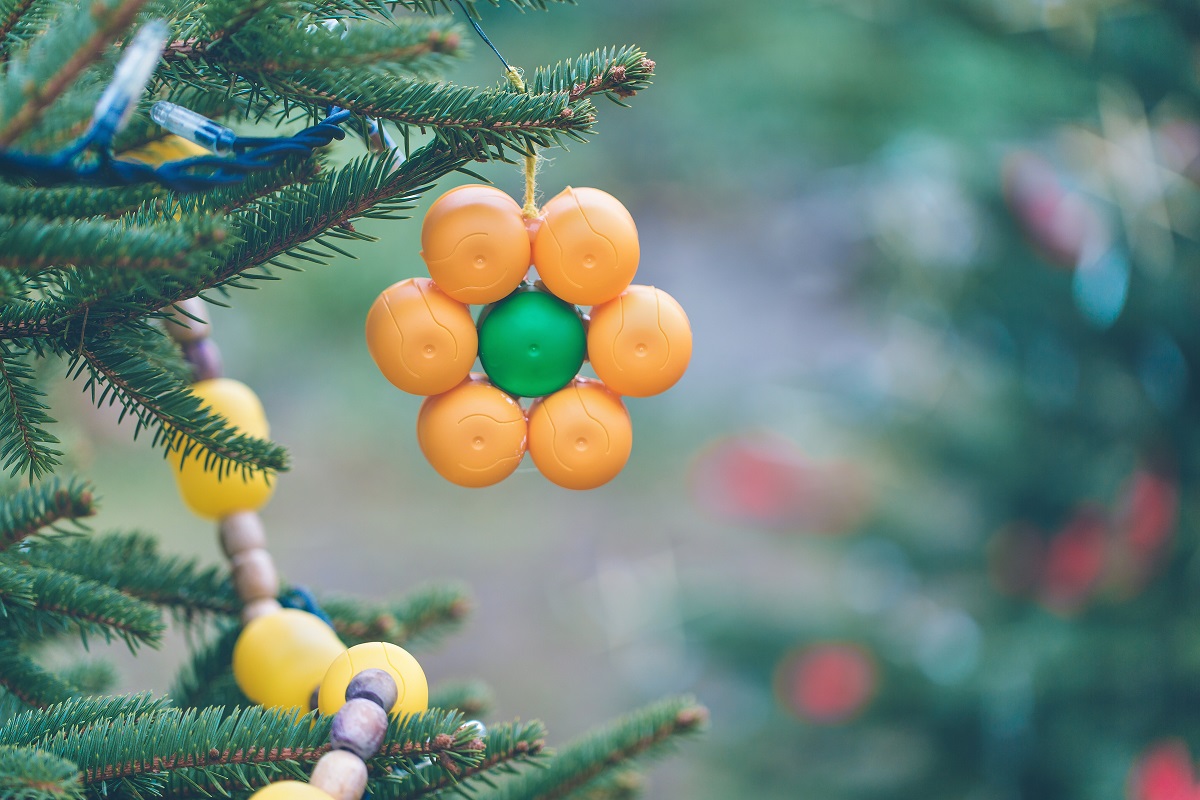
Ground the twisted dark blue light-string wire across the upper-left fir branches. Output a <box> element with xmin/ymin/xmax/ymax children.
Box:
<box><xmin>0</xmin><ymin>108</ymin><xmax>350</xmax><ymax>192</ymax></box>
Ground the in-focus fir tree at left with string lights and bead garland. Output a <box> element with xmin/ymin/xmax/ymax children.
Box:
<box><xmin>0</xmin><ymin>0</ymin><xmax>704</xmax><ymax>800</ymax></box>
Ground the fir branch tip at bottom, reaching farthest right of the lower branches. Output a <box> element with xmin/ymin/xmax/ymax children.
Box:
<box><xmin>477</xmin><ymin>698</ymin><xmax>708</xmax><ymax>800</ymax></box>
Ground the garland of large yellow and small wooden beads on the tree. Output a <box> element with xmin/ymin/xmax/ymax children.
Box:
<box><xmin>159</xmin><ymin>297</ymin><xmax>441</xmax><ymax>800</ymax></box>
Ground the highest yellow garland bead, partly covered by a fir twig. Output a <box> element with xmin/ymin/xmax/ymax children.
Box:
<box><xmin>168</xmin><ymin>378</ymin><xmax>275</xmax><ymax>519</ymax></box>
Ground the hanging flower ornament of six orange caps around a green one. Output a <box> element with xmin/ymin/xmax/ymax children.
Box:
<box><xmin>366</xmin><ymin>186</ymin><xmax>691</xmax><ymax>489</ymax></box>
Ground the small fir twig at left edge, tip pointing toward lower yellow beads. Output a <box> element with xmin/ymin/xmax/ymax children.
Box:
<box><xmin>0</xmin><ymin>563</ymin><xmax>163</xmax><ymax>650</ymax></box>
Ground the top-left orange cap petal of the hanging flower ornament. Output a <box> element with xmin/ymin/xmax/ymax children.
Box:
<box><xmin>421</xmin><ymin>184</ymin><xmax>529</xmax><ymax>305</ymax></box>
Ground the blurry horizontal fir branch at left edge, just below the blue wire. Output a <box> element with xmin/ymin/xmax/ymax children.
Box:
<box><xmin>0</xmin><ymin>213</ymin><xmax>228</xmax><ymax>272</ymax></box>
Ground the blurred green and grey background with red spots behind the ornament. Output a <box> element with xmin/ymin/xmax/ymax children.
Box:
<box><xmin>56</xmin><ymin>0</ymin><xmax>1200</xmax><ymax>800</ymax></box>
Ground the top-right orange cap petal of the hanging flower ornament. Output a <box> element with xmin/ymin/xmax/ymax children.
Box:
<box><xmin>533</xmin><ymin>187</ymin><xmax>641</xmax><ymax>306</ymax></box>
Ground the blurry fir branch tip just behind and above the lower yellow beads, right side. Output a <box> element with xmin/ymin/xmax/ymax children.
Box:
<box><xmin>322</xmin><ymin>585</ymin><xmax>470</xmax><ymax>646</ymax></box>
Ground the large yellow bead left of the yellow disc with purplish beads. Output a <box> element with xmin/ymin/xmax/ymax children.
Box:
<box><xmin>233</xmin><ymin>608</ymin><xmax>346</xmax><ymax>711</ymax></box>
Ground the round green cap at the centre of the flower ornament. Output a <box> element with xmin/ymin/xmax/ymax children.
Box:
<box><xmin>479</xmin><ymin>289</ymin><xmax>588</xmax><ymax>397</ymax></box>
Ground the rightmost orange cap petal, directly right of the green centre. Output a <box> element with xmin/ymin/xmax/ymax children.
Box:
<box><xmin>588</xmin><ymin>285</ymin><xmax>691</xmax><ymax>397</ymax></box>
